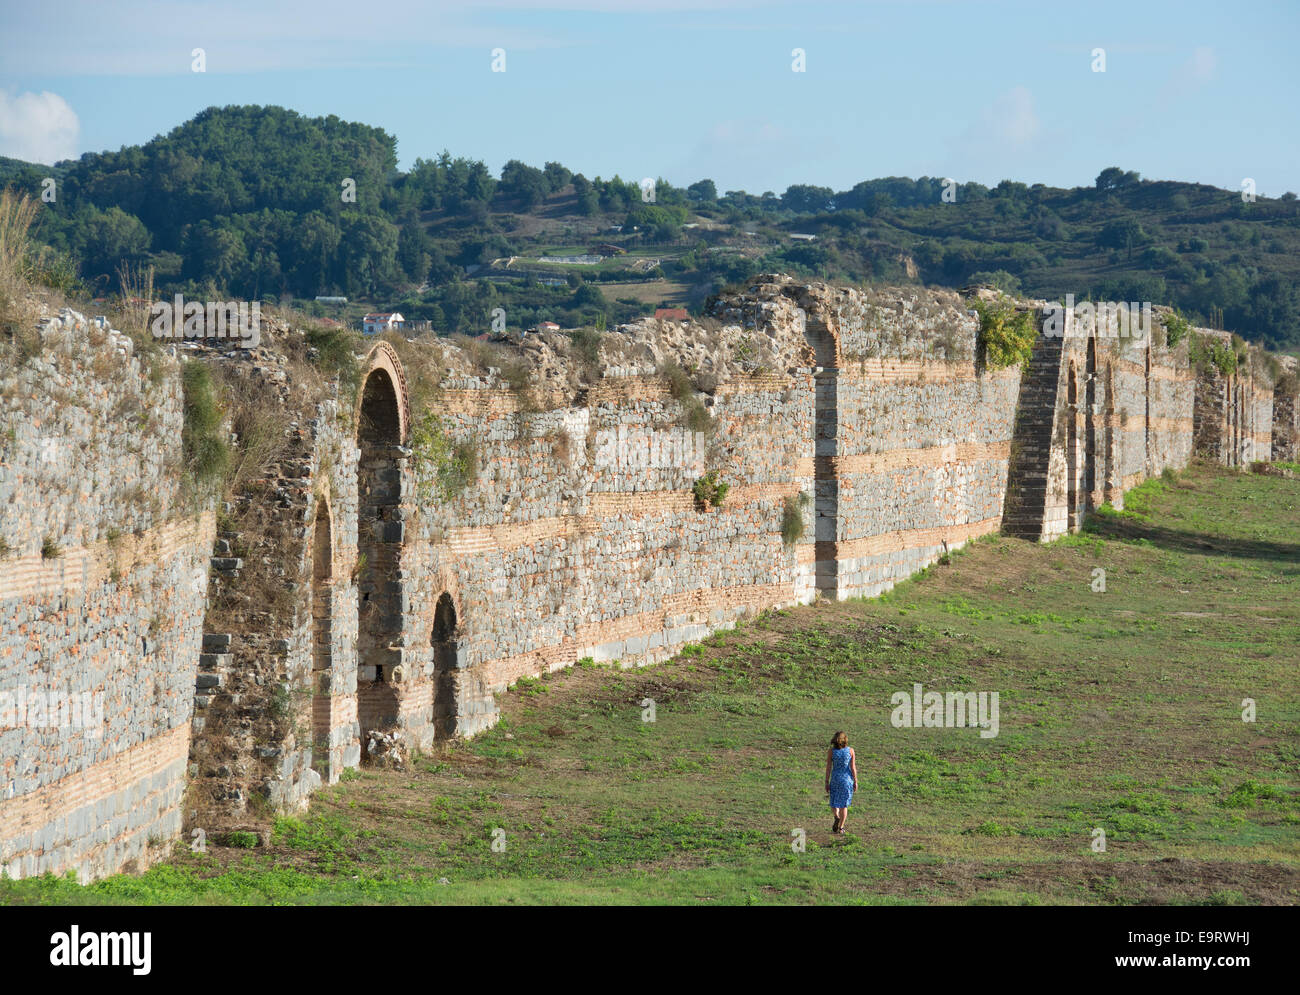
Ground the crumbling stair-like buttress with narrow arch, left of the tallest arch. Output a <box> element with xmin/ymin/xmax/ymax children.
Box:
<box><xmin>186</xmin><ymin>328</ymin><xmax>360</xmax><ymax>832</ymax></box>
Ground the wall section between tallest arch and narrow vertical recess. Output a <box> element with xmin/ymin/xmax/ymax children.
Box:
<box><xmin>379</xmin><ymin>356</ymin><xmax>813</xmax><ymax>747</ymax></box>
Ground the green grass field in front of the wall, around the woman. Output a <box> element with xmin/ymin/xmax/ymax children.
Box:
<box><xmin>0</xmin><ymin>467</ymin><xmax>1300</xmax><ymax>905</ymax></box>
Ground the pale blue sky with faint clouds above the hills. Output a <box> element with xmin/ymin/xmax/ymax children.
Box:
<box><xmin>0</xmin><ymin>0</ymin><xmax>1300</xmax><ymax>196</ymax></box>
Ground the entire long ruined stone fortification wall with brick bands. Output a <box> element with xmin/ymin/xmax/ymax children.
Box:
<box><xmin>0</xmin><ymin>277</ymin><xmax>1295</xmax><ymax>875</ymax></box>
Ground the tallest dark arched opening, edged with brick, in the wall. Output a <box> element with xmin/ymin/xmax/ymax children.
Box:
<box><xmin>356</xmin><ymin>367</ymin><xmax>403</xmax><ymax>750</ymax></box>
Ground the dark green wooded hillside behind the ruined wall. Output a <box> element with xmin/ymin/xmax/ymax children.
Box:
<box><xmin>10</xmin><ymin>107</ymin><xmax>1300</xmax><ymax>349</ymax></box>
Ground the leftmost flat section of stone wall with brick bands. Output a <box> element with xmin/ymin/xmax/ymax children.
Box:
<box><xmin>0</xmin><ymin>310</ymin><xmax>213</xmax><ymax>881</ymax></box>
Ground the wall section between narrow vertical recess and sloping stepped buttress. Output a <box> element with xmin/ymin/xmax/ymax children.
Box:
<box><xmin>781</xmin><ymin>279</ymin><xmax>1019</xmax><ymax>598</ymax></box>
